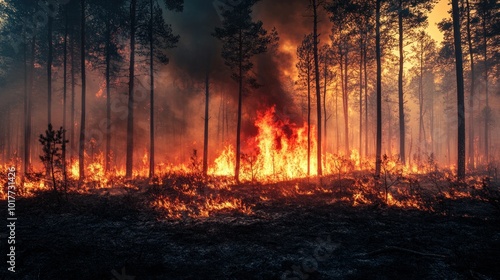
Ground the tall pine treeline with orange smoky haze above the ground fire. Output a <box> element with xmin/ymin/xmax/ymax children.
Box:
<box><xmin>0</xmin><ymin>0</ymin><xmax>500</xmax><ymax>181</ymax></box>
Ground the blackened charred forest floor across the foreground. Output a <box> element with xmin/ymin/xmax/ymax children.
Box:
<box><xmin>0</xmin><ymin>175</ymin><xmax>500</xmax><ymax>280</ymax></box>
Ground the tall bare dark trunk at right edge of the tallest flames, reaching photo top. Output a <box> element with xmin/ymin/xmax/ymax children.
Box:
<box><xmin>312</xmin><ymin>0</ymin><xmax>323</xmax><ymax>177</ymax></box>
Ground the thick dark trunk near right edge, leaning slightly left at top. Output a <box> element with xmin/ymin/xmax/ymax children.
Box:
<box><xmin>451</xmin><ymin>0</ymin><xmax>465</xmax><ymax>179</ymax></box>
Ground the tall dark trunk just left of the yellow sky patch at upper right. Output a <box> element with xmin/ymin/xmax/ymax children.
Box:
<box><xmin>398</xmin><ymin>0</ymin><xmax>406</xmax><ymax>164</ymax></box>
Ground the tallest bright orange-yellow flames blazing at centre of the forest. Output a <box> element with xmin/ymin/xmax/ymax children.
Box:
<box><xmin>210</xmin><ymin>107</ymin><xmax>317</xmax><ymax>182</ymax></box>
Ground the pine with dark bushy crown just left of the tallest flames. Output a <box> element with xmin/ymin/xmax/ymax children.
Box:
<box><xmin>213</xmin><ymin>0</ymin><xmax>277</xmax><ymax>182</ymax></box>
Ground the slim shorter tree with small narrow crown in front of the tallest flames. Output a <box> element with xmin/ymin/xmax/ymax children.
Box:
<box><xmin>296</xmin><ymin>34</ymin><xmax>314</xmax><ymax>176</ymax></box>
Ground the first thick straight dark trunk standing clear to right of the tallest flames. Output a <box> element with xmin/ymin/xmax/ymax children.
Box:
<box><xmin>375</xmin><ymin>0</ymin><xmax>382</xmax><ymax>177</ymax></box>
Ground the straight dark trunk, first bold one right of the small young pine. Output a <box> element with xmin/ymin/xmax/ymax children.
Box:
<box><xmin>78</xmin><ymin>0</ymin><xmax>86</xmax><ymax>181</ymax></box>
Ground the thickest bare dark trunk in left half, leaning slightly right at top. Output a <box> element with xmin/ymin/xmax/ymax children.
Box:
<box><xmin>125</xmin><ymin>0</ymin><xmax>137</xmax><ymax>178</ymax></box>
